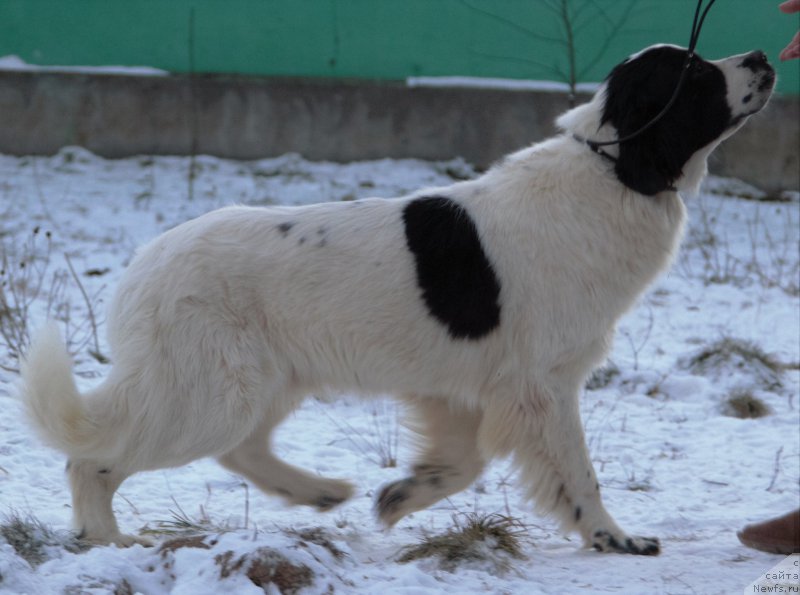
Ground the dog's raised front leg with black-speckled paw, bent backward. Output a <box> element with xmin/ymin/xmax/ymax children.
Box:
<box><xmin>375</xmin><ymin>398</ymin><xmax>485</xmax><ymax>526</ymax></box>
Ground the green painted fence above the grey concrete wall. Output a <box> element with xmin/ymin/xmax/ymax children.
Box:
<box><xmin>0</xmin><ymin>0</ymin><xmax>800</xmax><ymax>95</ymax></box>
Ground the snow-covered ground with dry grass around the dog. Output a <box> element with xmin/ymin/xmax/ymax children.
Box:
<box><xmin>0</xmin><ymin>148</ymin><xmax>800</xmax><ymax>595</ymax></box>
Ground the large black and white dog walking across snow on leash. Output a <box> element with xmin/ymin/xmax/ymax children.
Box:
<box><xmin>23</xmin><ymin>45</ymin><xmax>775</xmax><ymax>554</ymax></box>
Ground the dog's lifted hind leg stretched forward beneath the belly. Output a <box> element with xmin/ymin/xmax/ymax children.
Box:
<box><xmin>217</xmin><ymin>416</ymin><xmax>353</xmax><ymax>511</ymax></box>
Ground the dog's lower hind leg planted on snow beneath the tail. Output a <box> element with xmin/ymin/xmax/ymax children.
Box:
<box><xmin>67</xmin><ymin>460</ymin><xmax>152</xmax><ymax>547</ymax></box>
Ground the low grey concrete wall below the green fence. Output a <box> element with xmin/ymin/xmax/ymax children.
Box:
<box><xmin>0</xmin><ymin>72</ymin><xmax>800</xmax><ymax>191</ymax></box>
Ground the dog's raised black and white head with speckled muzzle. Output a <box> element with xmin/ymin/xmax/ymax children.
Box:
<box><xmin>558</xmin><ymin>45</ymin><xmax>775</xmax><ymax>195</ymax></box>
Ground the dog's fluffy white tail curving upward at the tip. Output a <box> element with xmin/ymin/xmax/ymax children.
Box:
<box><xmin>21</xmin><ymin>322</ymin><xmax>116</xmax><ymax>459</ymax></box>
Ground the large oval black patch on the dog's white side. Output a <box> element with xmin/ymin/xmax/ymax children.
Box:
<box><xmin>403</xmin><ymin>196</ymin><xmax>500</xmax><ymax>340</ymax></box>
